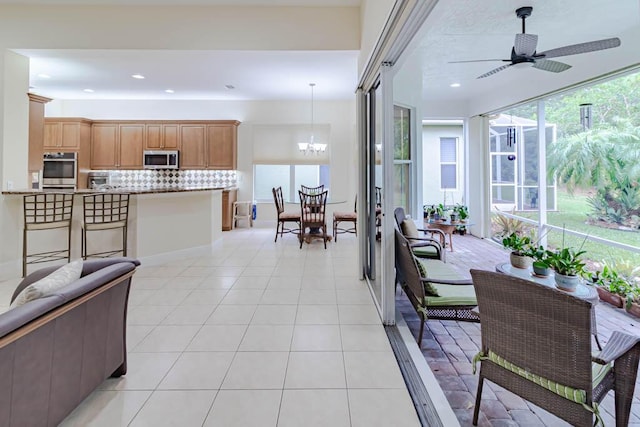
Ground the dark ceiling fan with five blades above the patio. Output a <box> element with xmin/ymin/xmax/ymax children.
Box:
<box><xmin>451</xmin><ymin>6</ymin><xmax>620</xmax><ymax>79</ymax></box>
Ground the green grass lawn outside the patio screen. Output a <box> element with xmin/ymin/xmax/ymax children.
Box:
<box><xmin>504</xmin><ymin>190</ymin><xmax>640</xmax><ymax>266</ymax></box>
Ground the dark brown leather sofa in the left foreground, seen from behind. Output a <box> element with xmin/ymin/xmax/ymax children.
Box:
<box><xmin>0</xmin><ymin>258</ymin><xmax>140</xmax><ymax>426</ymax></box>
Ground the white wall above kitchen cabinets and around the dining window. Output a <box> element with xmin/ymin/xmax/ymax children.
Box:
<box><xmin>45</xmin><ymin>100</ymin><xmax>357</xmax><ymax>220</ymax></box>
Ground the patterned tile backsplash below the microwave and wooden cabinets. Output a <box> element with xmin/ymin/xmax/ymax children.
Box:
<box><xmin>103</xmin><ymin>169</ymin><xmax>237</xmax><ymax>188</ymax></box>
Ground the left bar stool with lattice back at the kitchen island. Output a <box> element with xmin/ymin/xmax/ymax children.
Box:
<box><xmin>22</xmin><ymin>193</ymin><xmax>73</xmax><ymax>277</ymax></box>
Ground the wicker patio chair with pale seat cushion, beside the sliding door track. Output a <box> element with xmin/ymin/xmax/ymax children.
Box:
<box><xmin>395</xmin><ymin>230</ymin><xmax>480</xmax><ymax>346</ymax></box>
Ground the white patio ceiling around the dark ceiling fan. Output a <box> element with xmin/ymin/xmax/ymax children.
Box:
<box><xmin>416</xmin><ymin>0</ymin><xmax>640</xmax><ymax>104</ymax></box>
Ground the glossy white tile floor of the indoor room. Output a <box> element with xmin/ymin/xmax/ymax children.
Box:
<box><xmin>0</xmin><ymin>227</ymin><xmax>419</xmax><ymax>427</ymax></box>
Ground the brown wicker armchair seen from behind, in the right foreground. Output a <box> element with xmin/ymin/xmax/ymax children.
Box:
<box><xmin>471</xmin><ymin>270</ymin><xmax>640</xmax><ymax>426</ymax></box>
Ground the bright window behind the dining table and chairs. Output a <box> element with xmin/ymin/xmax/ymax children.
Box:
<box><xmin>253</xmin><ymin>165</ymin><xmax>330</xmax><ymax>202</ymax></box>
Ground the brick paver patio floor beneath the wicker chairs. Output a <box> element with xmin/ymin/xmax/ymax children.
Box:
<box><xmin>396</xmin><ymin>235</ymin><xmax>640</xmax><ymax>427</ymax></box>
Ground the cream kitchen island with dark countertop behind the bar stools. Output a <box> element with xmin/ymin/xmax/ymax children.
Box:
<box><xmin>0</xmin><ymin>187</ymin><xmax>224</xmax><ymax>280</ymax></box>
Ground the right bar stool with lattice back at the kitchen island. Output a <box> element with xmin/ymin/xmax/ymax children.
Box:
<box><xmin>82</xmin><ymin>193</ymin><xmax>129</xmax><ymax>259</ymax></box>
